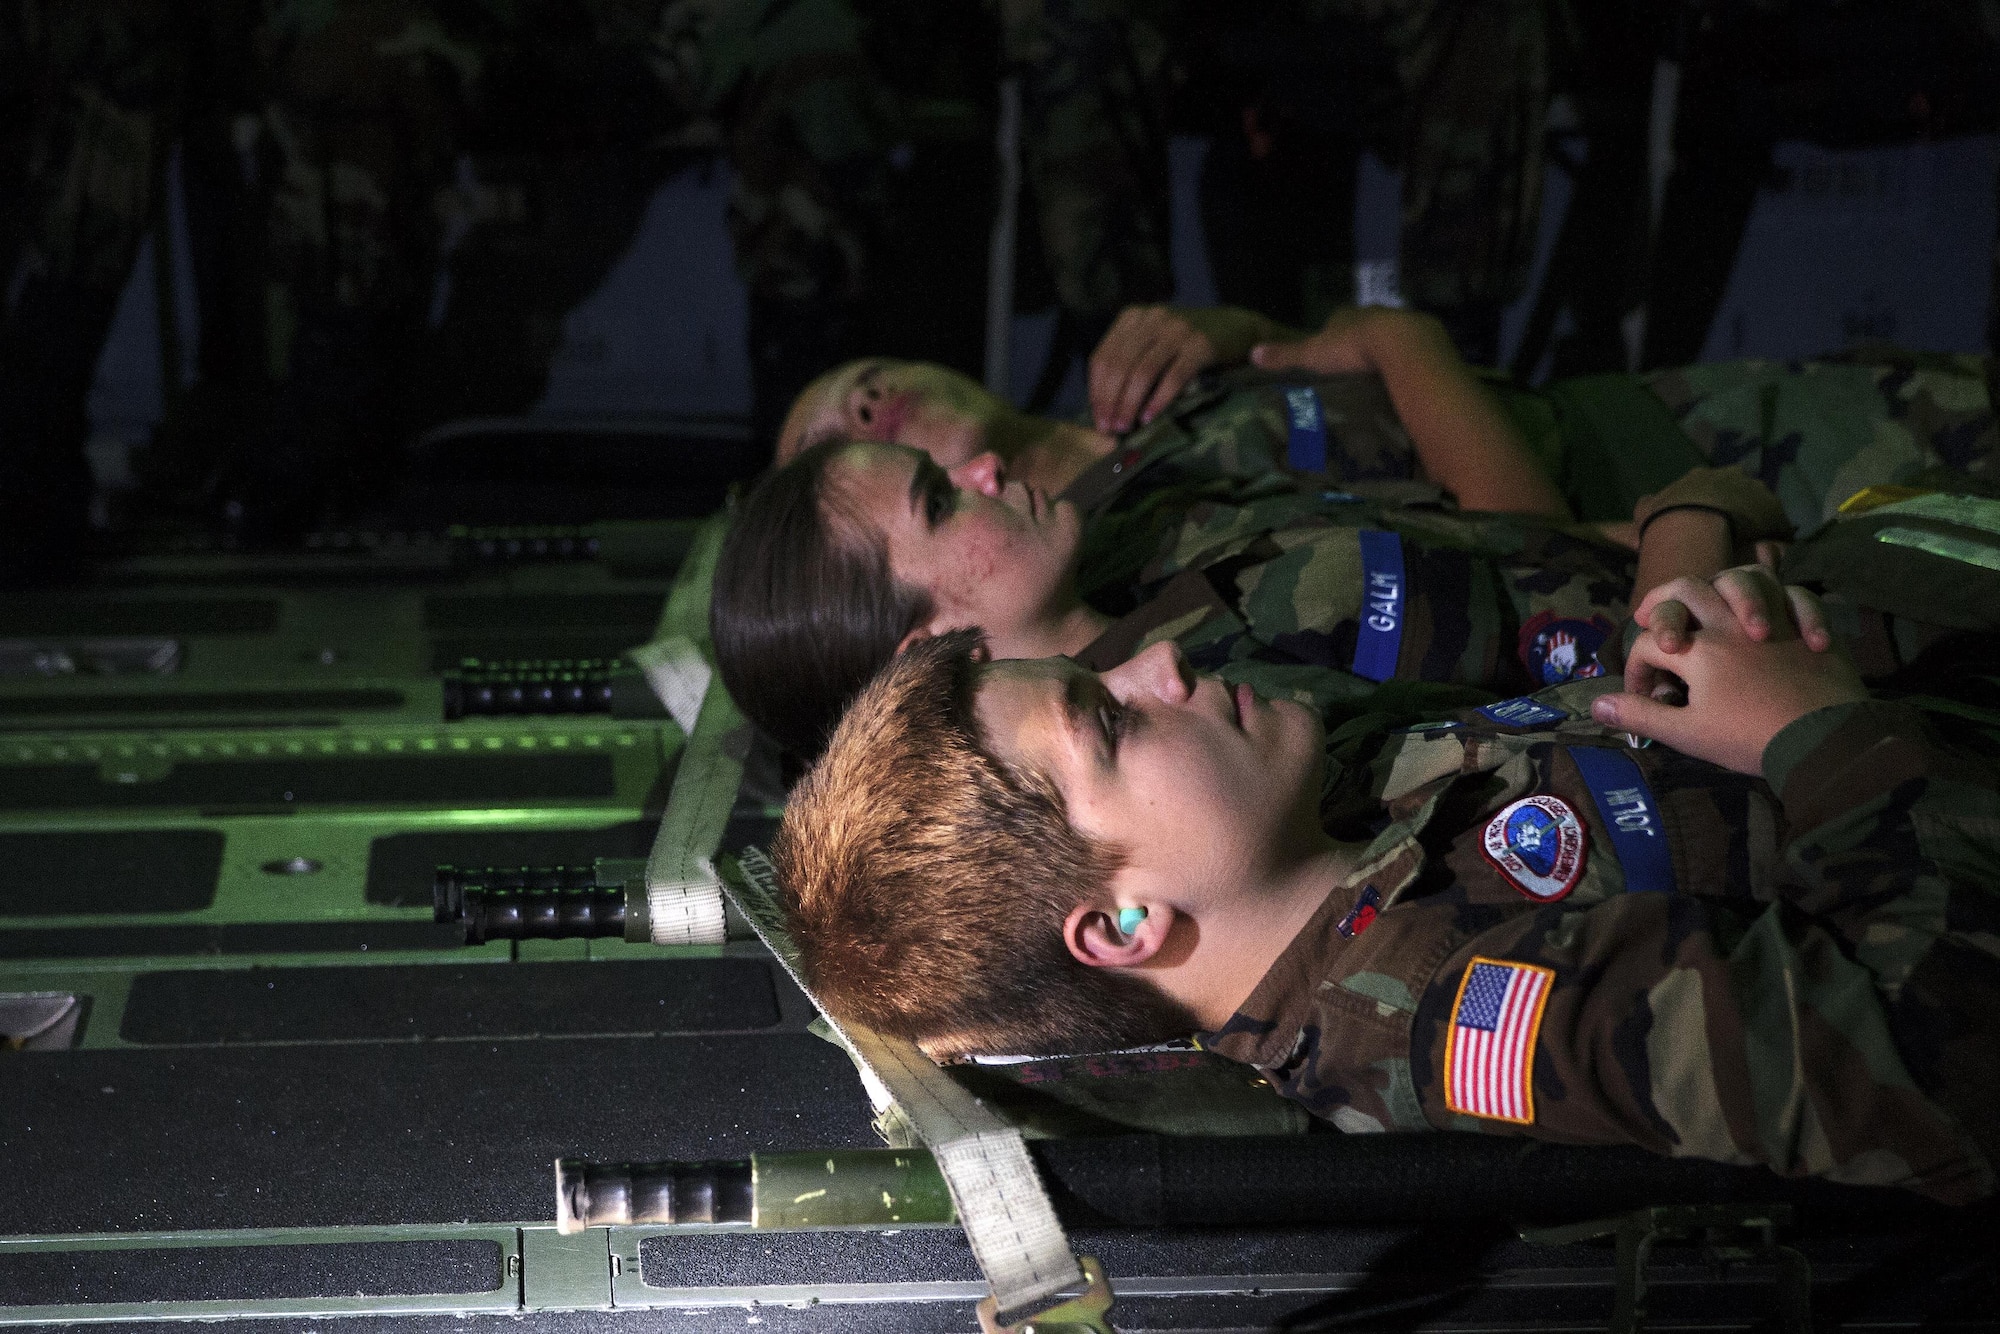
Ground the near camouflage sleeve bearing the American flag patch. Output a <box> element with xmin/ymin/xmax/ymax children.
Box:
<box><xmin>1412</xmin><ymin>702</ymin><xmax>2000</xmax><ymax>1202</ymax></box>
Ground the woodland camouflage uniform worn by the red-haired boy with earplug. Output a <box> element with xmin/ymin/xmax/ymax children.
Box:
<box><xmin>1204</xmin><ymin>682</ymin><xmax>2000</xmax><ymax>1202</ymax></box>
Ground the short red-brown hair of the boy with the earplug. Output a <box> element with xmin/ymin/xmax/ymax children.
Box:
<box><xmin>772</xmin><ymin>630</ymin><xmax>1198</xmax><ymax>1056</ymax></box>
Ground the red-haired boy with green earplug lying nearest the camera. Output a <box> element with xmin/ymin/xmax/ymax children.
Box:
<box><xmin>774</xmin><ymin>568</ymin><xmax>2000</xmax><ymax>1202</ymax></box>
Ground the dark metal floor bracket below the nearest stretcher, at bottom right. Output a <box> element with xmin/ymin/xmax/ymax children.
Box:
<box><xmin>1520</xmin><ymin>1204</ymin><xmax>1812</xmax><ymax>1334</ymax></box>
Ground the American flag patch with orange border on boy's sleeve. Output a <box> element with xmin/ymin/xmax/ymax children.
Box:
<box><xmin>1444</xmin><ymin>958</ymin><xmax>1556</xmax><ymax>1126</ymax></box>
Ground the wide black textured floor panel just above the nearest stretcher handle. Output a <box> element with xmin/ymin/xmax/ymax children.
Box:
<box><xmin>0</xmin><ymin>1032</ymin><xmax>880</xmax><ymax>1236</ymax></box>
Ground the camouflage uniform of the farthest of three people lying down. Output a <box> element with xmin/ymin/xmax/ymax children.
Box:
<box><xmin>1068</xmin><ymin>348</ymin><xmax>2000</xmax><ymax>552</ymax></box>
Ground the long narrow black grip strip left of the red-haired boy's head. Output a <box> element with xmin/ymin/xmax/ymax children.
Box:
<box><xmin>118</xmin><ymin>958</ymin><xmax>782</xmax><ymax>1044</ymax></box>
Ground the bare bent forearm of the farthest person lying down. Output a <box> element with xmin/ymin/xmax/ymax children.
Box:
<box><xmin>1362</xmin><ymin>310</ymin><xmax>1570</xmax><ymax>518</ymax></box>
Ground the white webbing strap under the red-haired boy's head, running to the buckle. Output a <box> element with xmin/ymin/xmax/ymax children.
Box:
<box><xmin>724</xmin><ymin>848</ymin><xmax>1084</xmax><ymax>1312</ymax></box>
